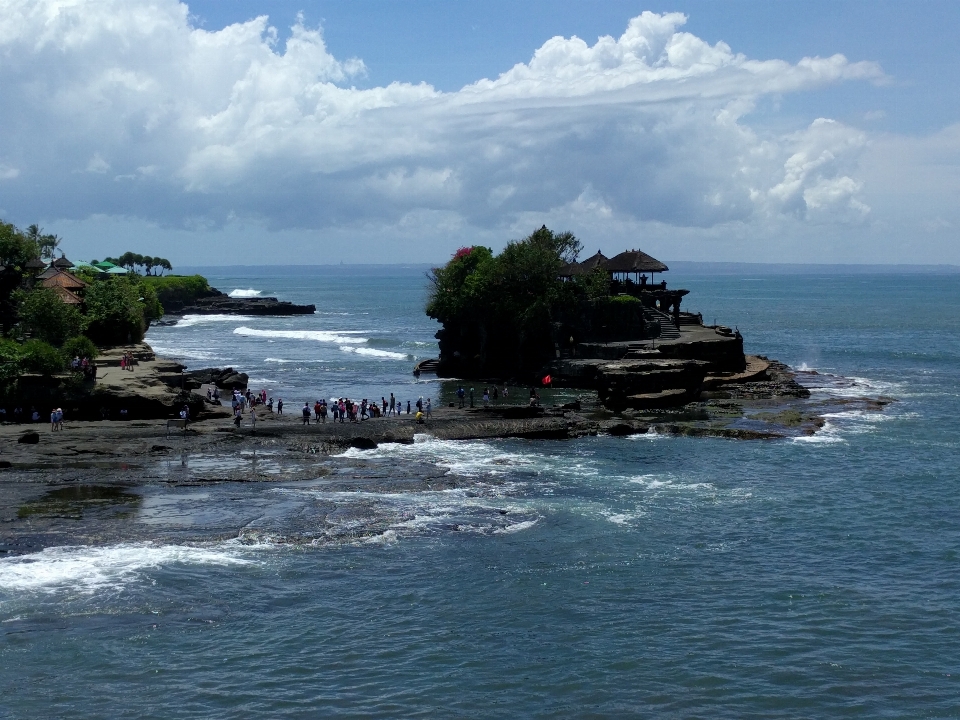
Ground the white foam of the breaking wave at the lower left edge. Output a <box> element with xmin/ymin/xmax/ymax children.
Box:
<box><xmin>0</xmin><ymin>544</ymin><xmax>251</xmax><ymax>592</ymax></box>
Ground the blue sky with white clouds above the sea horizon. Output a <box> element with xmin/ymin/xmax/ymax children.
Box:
<box><xmin>0</xmin><ymin>0</ymin><xmax>960</xmax><ymax>265</ymax></box>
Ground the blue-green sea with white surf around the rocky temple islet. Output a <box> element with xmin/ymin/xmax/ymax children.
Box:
<box><xmin>0</xmin><ymin>268</ymin><xmax>960</xmax><ymax>718</ymax></box>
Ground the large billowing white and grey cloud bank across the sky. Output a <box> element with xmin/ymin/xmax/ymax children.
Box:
<box><xmin>0</xmin><ymin>0</ymin><xmax>884</xmax><ymax>258</ymax></box>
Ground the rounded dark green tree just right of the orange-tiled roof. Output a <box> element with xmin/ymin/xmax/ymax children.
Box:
<box><xmin>85</xmin><ymin>275</ymin><xmax>147</xmax><ymax>345</ymax></box>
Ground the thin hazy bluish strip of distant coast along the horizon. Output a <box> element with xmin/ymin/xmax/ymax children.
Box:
<box><xmin>174</xmin><ymin>260</ymin><xmax>960</xmax><ymax>275</ymax></box>
